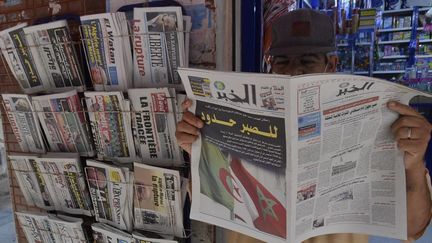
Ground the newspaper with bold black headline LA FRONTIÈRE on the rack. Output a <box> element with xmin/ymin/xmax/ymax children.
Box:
<box><xmin>128</xmin><ymin>88</ymin><xmax>182</xmax><ymax>165</ymax></box>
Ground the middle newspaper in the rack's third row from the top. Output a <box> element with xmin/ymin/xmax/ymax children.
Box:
<box><xmin>86</xmin><ymin>160</ymin><xmax>133</xmax><ymax>231</ymax></box>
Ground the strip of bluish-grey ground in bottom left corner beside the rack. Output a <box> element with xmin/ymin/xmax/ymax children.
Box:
<box><xmin>0</xmin><ymin>174</ymin><xmax>17</xmax><ymax>243</ymax></box>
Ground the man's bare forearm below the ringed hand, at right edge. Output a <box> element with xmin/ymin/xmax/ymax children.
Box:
<box><xmin>405</xmin><ymin>163</ymin><xmax>432</xmax><ymax>237</ymax></box>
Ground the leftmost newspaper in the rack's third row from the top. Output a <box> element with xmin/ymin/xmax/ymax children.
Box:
<box><xmin>9</xmin><ymin>153</ymin><xmax>92</xmax><ymax>216</ymax></box>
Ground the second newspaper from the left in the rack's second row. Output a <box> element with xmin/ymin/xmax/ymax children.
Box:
<box><xmin>32</xmin><ymin>90</ymin><xmax>94</xmax><ymax>156</ymax></box>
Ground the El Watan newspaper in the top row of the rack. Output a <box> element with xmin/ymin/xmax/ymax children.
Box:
<box><xmin>81</xmin><ymin>12</ymin><xmax>133</xmax><ymax>91</ymax></box>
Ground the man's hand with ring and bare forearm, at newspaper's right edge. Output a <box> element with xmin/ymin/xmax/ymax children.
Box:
<box><xmin>388</xmin><ymin>102</ymin><xmax>432</xmax><ymax>238</ymax></box>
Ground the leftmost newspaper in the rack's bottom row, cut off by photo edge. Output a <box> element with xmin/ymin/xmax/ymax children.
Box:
<box><xmin>16</xmin><ymin>212</ymin><xmax>88</xmax><ymax>243</ymax></box>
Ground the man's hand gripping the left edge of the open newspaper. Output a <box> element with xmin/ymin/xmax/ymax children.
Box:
<box><xmin>176</xmin><ymin>99</ymin><xmax>204</xmax><ymax>154</ymax></box>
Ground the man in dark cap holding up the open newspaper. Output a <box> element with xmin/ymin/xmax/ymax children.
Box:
<box><xmin>176</xmin><ymin>9</ymin><xmax>432</xmax><ymax>243</ymax></box>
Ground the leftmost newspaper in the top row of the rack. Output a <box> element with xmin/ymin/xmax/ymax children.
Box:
<box><xmin>0</xmin><ymin>23</ymin><xmax>49</xmax><ymax>94</ymax></box>
